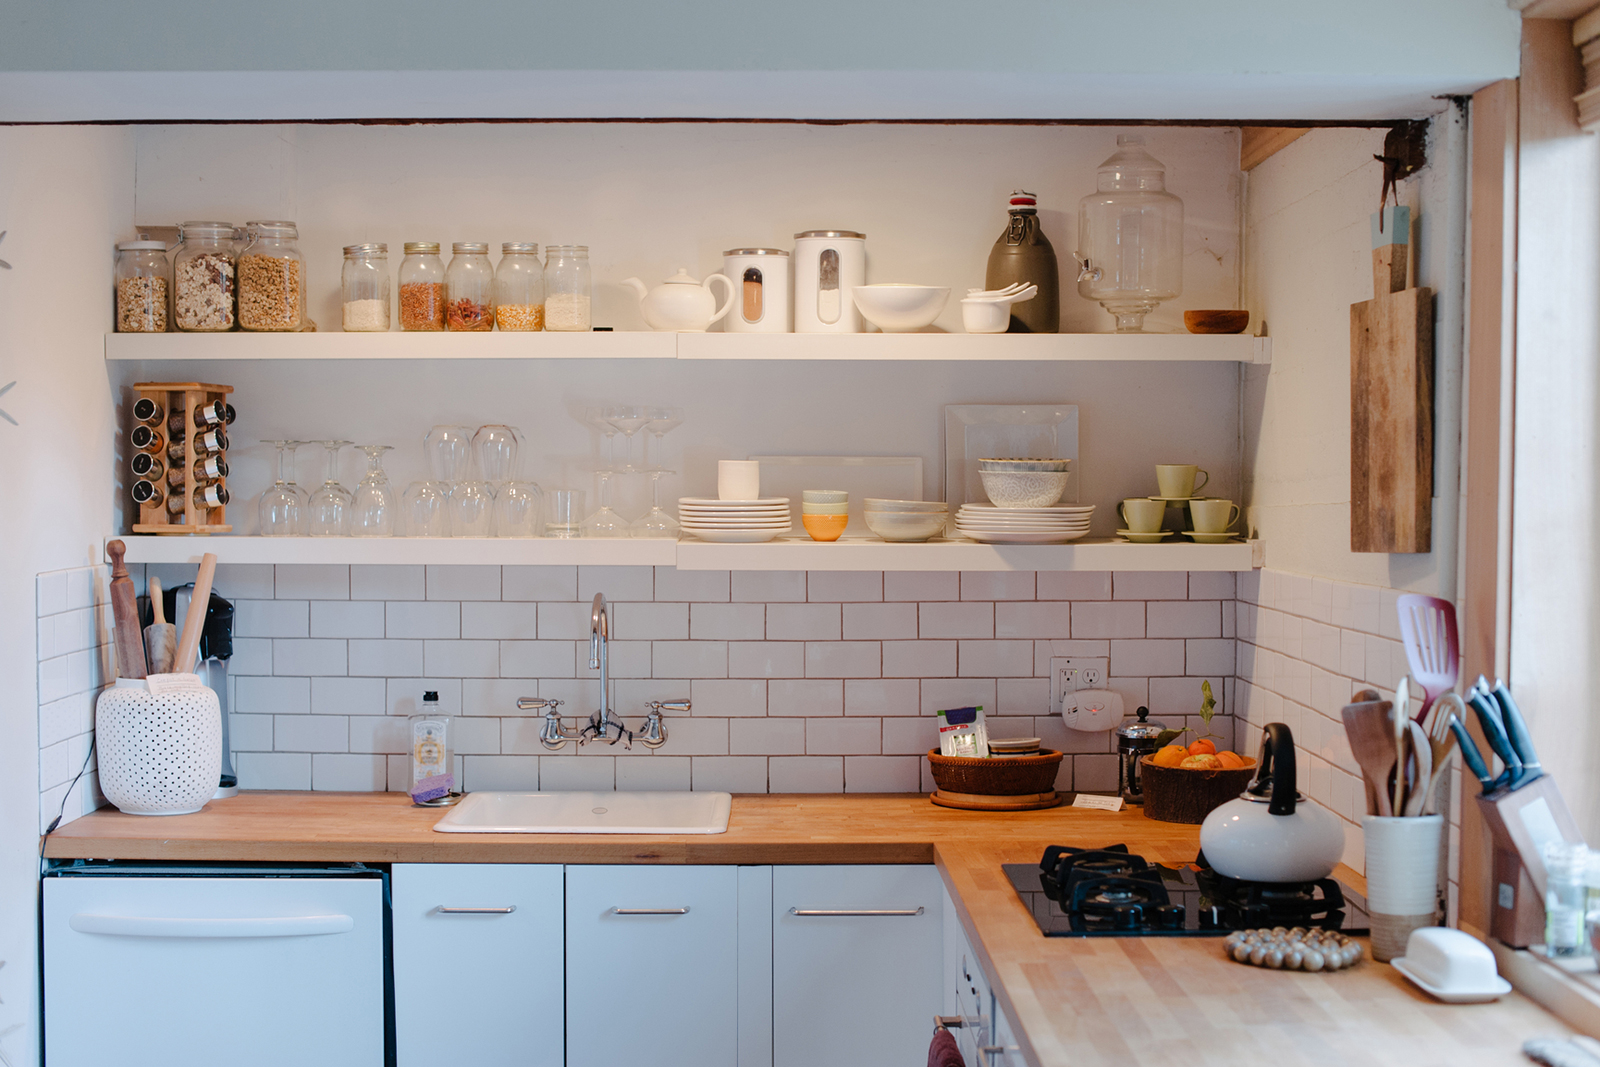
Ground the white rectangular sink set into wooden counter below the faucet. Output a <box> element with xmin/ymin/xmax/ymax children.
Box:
<box><xmin>434</xmin><ymin>793</ymin><xmax>733</xmax><ymax>833</ymax></box>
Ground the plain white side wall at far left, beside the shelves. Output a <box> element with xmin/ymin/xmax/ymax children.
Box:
<box><xmin>0</xmin><ymin>128</ymin><xmax>133</xmax><ymax>1067</ymax></box>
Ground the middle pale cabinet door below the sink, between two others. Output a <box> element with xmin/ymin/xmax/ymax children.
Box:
<box><xmin>566</xmin><ymin>865</ymin><xmax>739</xmax><ymax>1067</ymax></box>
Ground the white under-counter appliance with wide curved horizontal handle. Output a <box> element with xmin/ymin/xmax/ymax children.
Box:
<box><xmin>43</xmin><ymin>864</ymin><xmax>386</xmax><ymax>1067</ymax></box>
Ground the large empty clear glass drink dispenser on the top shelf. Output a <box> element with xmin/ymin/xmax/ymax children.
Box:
<box><xmin>1074</xmin><ymin>134</ymin><xmax>1184</xmax><ymax>333</ymax></box>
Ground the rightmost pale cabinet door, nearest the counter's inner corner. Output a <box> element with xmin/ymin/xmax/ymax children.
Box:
<box><xmin>773</xmin><ymin>865</ymin><xmax>944</xmax><ymax>1067</ymax></box>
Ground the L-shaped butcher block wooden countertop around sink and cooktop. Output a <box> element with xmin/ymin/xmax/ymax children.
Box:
<box><xmin>45</xmin><ymin>793</ymin><xmax>1570</xmax><ymax>1067</ymax></box>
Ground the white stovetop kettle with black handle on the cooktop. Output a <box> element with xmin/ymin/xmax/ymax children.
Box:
<box><xmin>1200</xmin><ymin>723</ymin><xmax>1344</xmax><ymax>881</ymax></box>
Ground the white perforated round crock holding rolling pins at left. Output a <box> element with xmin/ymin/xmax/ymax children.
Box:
<box><xmin>94</xmin><ymin>675</ymin><xmax>222</xmax><ymax>816</ymax></box>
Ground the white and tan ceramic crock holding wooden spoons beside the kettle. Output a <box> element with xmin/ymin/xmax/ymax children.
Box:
<box><xmin>1362</xmin><ymin>816</ymin><xmax>1445</xmax><ymax>963</ymax></box>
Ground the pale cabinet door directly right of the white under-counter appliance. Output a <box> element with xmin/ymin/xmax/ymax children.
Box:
<box><xmin>390</xmin><ymin>864</ymin><xmax>565</xmax><ymax>1067</ymax></box>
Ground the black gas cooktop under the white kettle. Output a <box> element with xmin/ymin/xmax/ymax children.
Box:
<box><xmin>1002</xmin><ymin>845</ymin><xmax>1368</xmax><ymax>937</ymax></box>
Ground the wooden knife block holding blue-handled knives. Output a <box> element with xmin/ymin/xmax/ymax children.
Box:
<box><xmin>1477</xmin><ymin>774</ymin><xmax>1584</xmax><ymax>949</ymax></box>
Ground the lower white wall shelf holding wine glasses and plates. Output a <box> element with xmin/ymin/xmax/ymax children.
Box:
<box><xmin>109</xmin><ymin>534</ymin><xmax>1262</xmax><ymax>571</ymax></box>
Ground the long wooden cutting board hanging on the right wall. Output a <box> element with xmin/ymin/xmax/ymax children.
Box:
<box><xmin>1350</xmin><ymin>208</ymin><xmax>1434</xmax><ymax>552</ymax></box>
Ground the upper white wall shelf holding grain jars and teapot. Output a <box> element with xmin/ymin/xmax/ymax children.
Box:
<box><xmin>106</xmin><ymin>331</ymin><xmax>1272</xmax><ymax>363</ymax></box>
